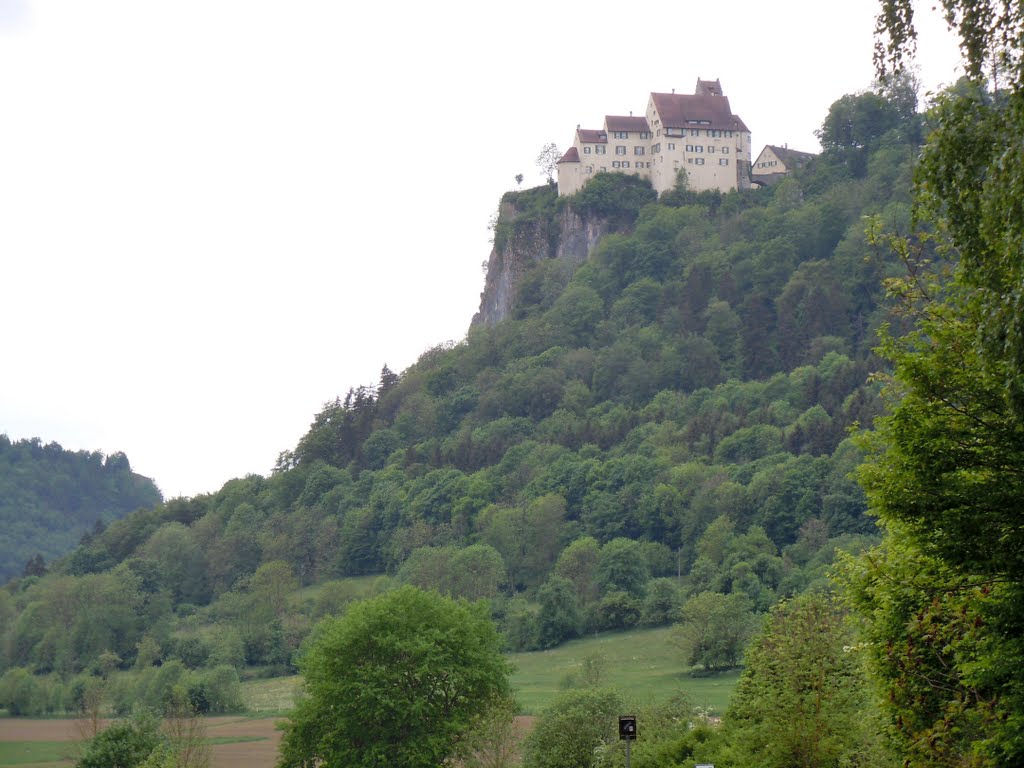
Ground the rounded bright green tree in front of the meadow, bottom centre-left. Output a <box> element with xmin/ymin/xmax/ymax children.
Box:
<box><xmin>279</xmin><ymin>587</ymin><xmax>509</xmax><ymax>768</ymax></box>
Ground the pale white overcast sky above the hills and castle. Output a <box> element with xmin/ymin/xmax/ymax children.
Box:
<box><xmin>0</xmin><ymin>0</ymin><xmax>955</xmax><ymax>497</ymax></box>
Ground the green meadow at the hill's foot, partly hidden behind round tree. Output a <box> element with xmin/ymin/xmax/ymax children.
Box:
<box><xmin>235</xmin><ymin>628</ymin><xmax>739</xmax><ymax>715</ymax></box>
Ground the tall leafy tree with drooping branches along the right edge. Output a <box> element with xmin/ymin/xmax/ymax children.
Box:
<box><xmin>846</xmin><ymin>0</ymin><xmax>1024</xmax><ymax>766</ymax></box>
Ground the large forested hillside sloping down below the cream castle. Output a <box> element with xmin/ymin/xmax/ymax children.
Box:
<box><xmin>0</xmin><ymin>78</ymin><xmax>921</xmax><ymax>710</ymax></box>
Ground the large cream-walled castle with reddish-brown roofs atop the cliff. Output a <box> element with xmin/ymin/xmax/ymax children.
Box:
<box><xmin>558</xmin><ymin>80</ymin><xmax>751</xmax><ymax>195</ymax></box>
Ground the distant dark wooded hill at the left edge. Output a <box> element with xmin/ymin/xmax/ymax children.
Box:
<box><xmin>0</xmin><ymin>434</ymin><xmax>161</xmax><ymax>582</ymax></box>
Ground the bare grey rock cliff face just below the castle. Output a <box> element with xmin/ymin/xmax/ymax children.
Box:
<box><xmin>471</xmin><ymin>203</ymin><xmax>611</xmax><ymax>326</ymax></box>
